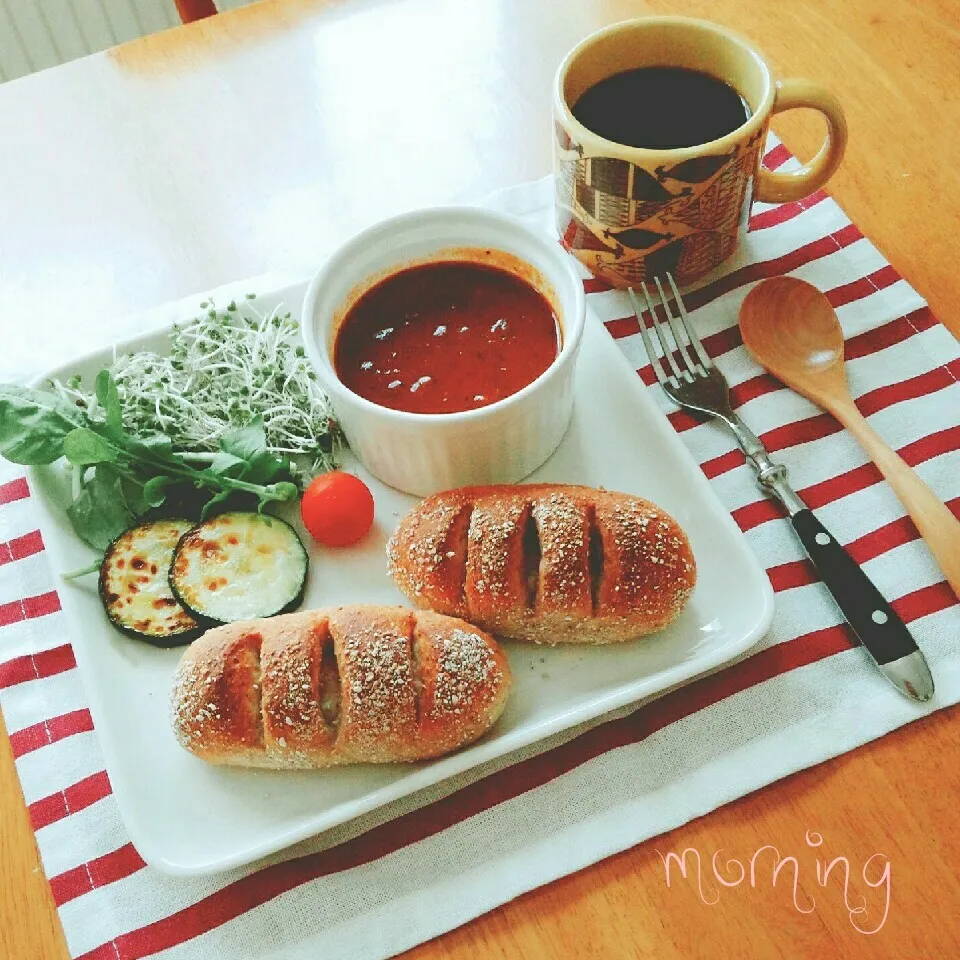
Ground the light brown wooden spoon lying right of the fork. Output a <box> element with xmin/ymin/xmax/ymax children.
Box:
<box><xmin>740</xmin><ymin>277</ymin><xmax>960</xmax><ymax>596</ymax></box>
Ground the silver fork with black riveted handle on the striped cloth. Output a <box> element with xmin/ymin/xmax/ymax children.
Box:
<box><xmin>628</xmin><ymin>273</ymin><xmax>933</xmax><ymax>700</ymax></box>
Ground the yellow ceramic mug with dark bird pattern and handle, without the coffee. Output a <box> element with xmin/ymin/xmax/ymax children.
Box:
<box><xmin>553</xmin><ymin>17</ymin><xmax>847</xmax><ymax>287</ymax></box>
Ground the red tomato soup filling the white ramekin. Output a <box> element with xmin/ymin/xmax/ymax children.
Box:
<box><xmin>334</xmin><ymin>261</ymin><xmax>562</xmax><ymax>413</ymax></box>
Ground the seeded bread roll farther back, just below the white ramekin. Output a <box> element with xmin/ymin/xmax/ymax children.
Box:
<box><xmin>387</xmin><ymin>483</ymin><xmax>697</xmax><ymax>644</ymax></box>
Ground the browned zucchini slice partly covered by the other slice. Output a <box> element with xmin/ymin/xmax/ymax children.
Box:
<box><xmin>99</xmin><ymin>520</ymin><xmax>202</xmax><ymax>647</ymax></box>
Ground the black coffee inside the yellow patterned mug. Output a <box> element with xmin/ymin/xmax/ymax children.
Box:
<box><xmin>573</xmin><ymin>67</ymin><xmax>750</xmax><ymax>150</ymax></box>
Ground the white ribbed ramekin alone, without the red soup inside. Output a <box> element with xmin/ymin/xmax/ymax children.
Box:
<box><xmin>301</xmin><ymin>207</ymin><xmax>585</xmax><ymax>496</ymax></box>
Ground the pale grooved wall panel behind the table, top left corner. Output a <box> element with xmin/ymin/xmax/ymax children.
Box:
<box><xmin>0</xmin><ymin>0</ymin><xmax>249</xmax><ymax>82</ymax></box>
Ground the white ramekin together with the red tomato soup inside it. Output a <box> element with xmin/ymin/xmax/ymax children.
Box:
<box><xmin>301</xmin><ymin>207</ymin><xmax>585</xmax><ymax>496</ymax></box>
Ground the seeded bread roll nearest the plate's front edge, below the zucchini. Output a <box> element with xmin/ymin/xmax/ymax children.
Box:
<box><xmin>172</xmin><ymin>606</ymin><xmax>511</xmax><ymax>768</ymax></box>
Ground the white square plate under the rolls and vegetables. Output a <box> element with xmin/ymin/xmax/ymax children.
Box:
<box><xmin>30</xmin><ymin>284</ymin><xmax>773</xmax><ymax>875</ymax></box>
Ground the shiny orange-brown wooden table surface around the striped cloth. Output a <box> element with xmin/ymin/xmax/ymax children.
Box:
<box><xmin>0</xmin><ymin>0</ymin><xmax>960</xmax><ymax>960</ymax></box>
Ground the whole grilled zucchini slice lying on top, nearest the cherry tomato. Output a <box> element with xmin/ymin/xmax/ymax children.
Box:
<box><xmin>170</xmin><ymin>512</ymin><xmax>307</xmax><ymax>623</ymax></box>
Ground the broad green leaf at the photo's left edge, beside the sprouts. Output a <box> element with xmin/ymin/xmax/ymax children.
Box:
<box><xmin>0</xmin><ymin>384</ymin><xmax>86</xmax><ymax>464</ymax></box>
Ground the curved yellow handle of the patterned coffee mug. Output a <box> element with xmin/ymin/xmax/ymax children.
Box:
<box><xmin>756</xmin><ymin>79</ymin><xmax>847</xmax><ymax>203</ymax></box>
